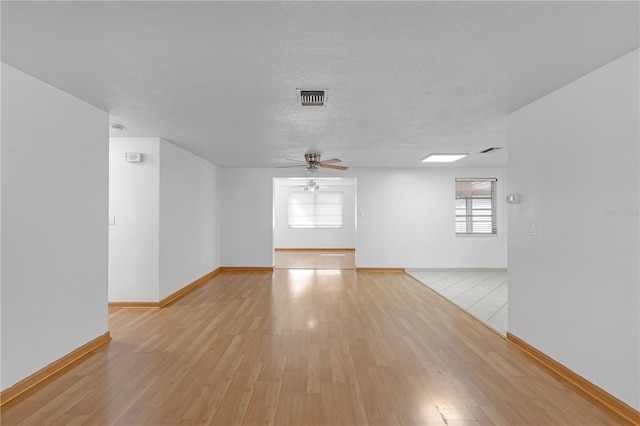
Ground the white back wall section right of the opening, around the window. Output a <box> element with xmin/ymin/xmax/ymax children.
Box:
<box><xmin>356</xmin><ymin>168</ymin><xmax>507</xmax><ymax>268</ymax></box>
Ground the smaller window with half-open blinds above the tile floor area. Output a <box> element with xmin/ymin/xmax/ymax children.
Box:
<box><xmin>456</xmin><ymin>179</ymin><xmax>498</xmax><ymax>235</ymax></box>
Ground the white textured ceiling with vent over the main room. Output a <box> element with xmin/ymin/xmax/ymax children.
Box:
<box><xmin>0</xmin><ymin>1</ymin><xmax>639</xmax><ymax>167</ymax></box>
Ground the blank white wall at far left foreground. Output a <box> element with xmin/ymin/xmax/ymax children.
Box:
<box><xmin>1</xmin><ymin>64</ymin><xmax>109</xmax><ymax>390</ymax></box>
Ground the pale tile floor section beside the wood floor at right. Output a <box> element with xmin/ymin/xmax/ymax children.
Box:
<box><xmin>407</xmin><ymin>269</ymin><xmax>509</xmax><ymax>335</ymax></box>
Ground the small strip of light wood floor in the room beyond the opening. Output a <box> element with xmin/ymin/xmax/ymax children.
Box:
<box><xmin>274</xmin><ymin>249</ymin><xmax>356</xmax><ymax>269</ymax></box>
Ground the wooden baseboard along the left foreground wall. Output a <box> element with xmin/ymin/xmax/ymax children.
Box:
<box><xmin>0</xmin><ymin>331</ymin><xmax>111</xmax><ymax>406</ymax></box>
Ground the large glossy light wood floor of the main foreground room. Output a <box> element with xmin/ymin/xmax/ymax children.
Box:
<box><xmin>2</xmin><ymin>270</ymin><xmax>624</xmax><ymax>426</ymax></box>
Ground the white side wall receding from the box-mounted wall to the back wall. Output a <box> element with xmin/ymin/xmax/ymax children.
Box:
<box><xmin>160</xmin><ymin>140</ymin><xmax>220</xmax><ymax>300</ymax></box>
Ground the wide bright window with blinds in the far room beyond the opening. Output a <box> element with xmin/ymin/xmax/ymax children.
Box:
<box><xmin>289</xmin><ymin>191</ymin><xmax>343</xmax><ymax>228</ymax></box>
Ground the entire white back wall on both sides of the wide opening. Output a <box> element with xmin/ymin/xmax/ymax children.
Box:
<box><xmin>221</xmin><ymin>167</ymin><xmax>507</xmax><ymax>268</ymax></box>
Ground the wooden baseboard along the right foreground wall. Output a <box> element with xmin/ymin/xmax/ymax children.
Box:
<box><xmin>507</xmin><ymin>332</ymin><xmax>640</xmax><ymax>424</ymax></box>
